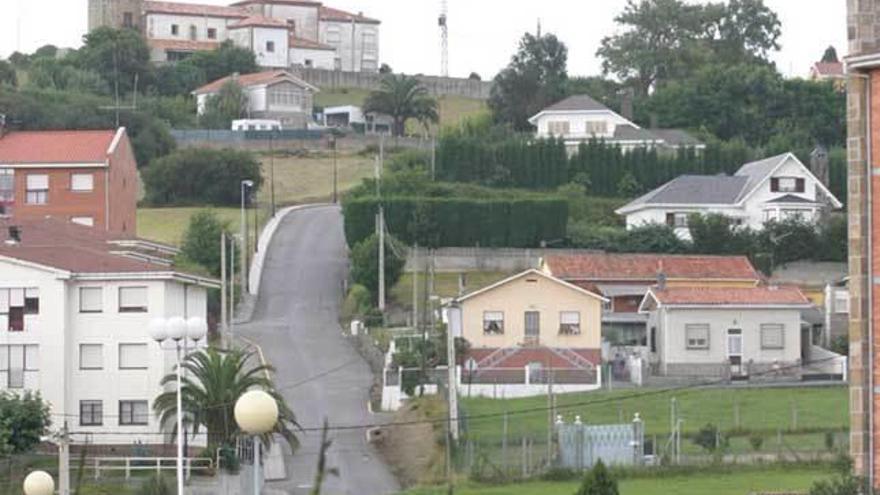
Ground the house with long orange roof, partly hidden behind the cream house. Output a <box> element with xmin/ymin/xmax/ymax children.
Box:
<box><xmin>541</xmin><ymin>253</ymin><xmax>762</xmax><ymax>359</ymax></box>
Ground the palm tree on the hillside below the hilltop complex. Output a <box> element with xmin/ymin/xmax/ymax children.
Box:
<box><xmin>364</xmin><ymin>74</ymin><xmax>439</xmax><ymax>136</ymax></box>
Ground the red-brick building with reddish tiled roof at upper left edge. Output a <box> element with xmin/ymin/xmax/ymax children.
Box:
<box><xmin>0</xmin><ymin>128</ymin><xmax>138</xmax><ymax>236</ymax></box>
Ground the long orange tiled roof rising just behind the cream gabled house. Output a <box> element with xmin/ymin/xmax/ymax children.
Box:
<box><xmin>545</xmin><ymin>253</ymin><xmax>762</xmax><ymax>282</ymax></box>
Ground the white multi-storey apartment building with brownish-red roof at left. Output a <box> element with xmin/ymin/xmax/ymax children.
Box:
<box><xmin>0</xmin><ymin>218</ymin><xmax>218</xmax><ymax>446</ymax></box>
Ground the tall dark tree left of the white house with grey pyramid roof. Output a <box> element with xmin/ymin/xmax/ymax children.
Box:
<box><xmin>489</xmin><ymin>33</ymin><xmax>568</xmax><ymax>131</ymax></box>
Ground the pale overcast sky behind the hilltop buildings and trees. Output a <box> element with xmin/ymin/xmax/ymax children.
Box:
<box><xmin>0</xmin><ymin>0</ymin><xmax>846</xmax><ymax>79</ymax></box>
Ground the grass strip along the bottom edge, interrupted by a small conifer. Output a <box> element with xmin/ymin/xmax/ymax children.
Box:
<box><xmin>406</xmin><ymin>467</ymin><xmax>832</xmax><ymax>495</ymax></box>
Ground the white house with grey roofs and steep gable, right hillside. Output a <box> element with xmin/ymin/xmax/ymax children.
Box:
<box><xmin>616</xmin><ymin>153</ymin><xmax>843</xmax><ymax>239</ymax></box>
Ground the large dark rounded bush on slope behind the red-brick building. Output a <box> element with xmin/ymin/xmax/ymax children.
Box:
<box><xmin>143</xmin><ymin>149</ymin><xmax>263</xmax><ymax>205</ymax></box>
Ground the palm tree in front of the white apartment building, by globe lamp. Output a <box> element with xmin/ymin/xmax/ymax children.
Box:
<box><xmin>153</xmin><ymin>348</ymin><xmax>299</xmax><ymax>450</ymax></box>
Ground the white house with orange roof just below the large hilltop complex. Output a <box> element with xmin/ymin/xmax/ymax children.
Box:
<box><xmin>193</xmin><ymin>70</ymin><xmax>318</xmax><ymax>129</ymax></box>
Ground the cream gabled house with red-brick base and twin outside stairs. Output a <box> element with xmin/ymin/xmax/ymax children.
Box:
<box><xmin>456</xmin><ymin>270</ymin><xmax>607</xmax><ymax>395</ymax></box>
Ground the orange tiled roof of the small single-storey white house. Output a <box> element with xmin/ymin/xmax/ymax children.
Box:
<box><xmin>651</xmin><ymin>286</ymin><xmax>811</xmax><ymax>307</ymax></box>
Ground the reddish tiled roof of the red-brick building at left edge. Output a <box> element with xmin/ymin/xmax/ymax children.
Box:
<box><xmin>0</xmin><ymin>130</ymin><xmax>117</xmax><ymax>164</ymax></box>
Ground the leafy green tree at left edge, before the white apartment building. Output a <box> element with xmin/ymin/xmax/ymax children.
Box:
<box><xmin>0</xmin><ymin>391</ymin><xmax>51</xmax><ymax>455</ymax></box>
